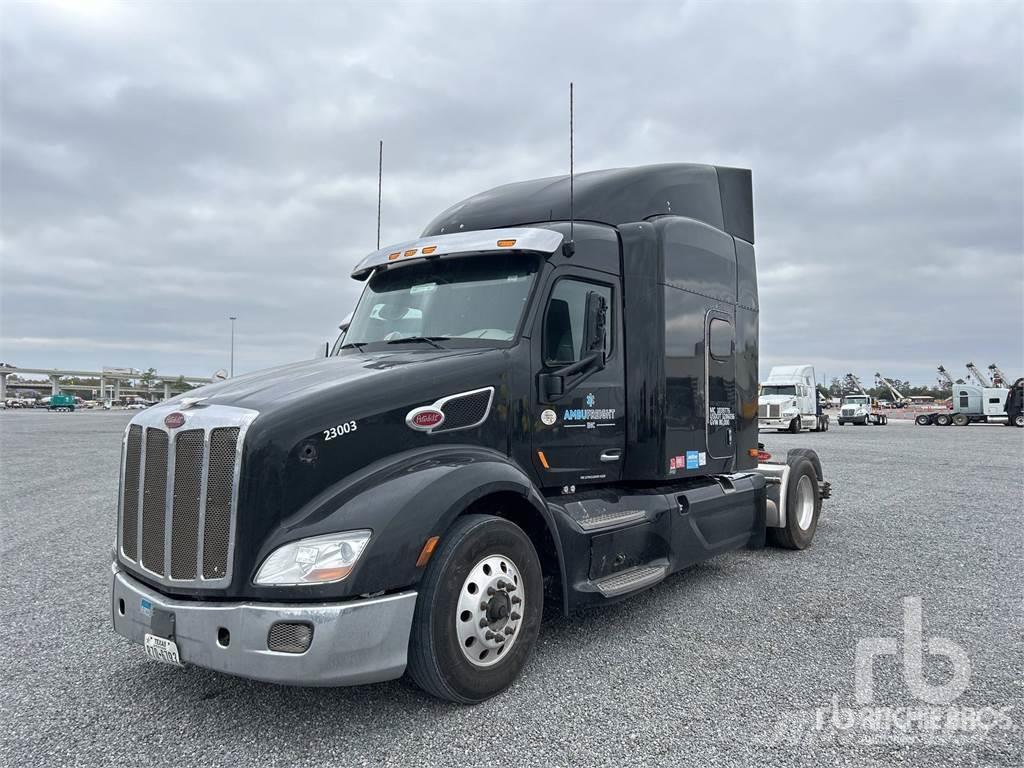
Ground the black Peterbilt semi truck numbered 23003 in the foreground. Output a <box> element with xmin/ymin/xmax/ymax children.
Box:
<box><xmin>112</xmin><ymin>164</ymin><xmax>828</xmax><ymax>703</ymax></box>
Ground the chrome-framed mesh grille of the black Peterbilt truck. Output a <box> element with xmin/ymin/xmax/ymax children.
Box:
<box><xmin>118</xmin><ymin>406</ymin><xmax>257</xmax><ymax>587</ymax></box>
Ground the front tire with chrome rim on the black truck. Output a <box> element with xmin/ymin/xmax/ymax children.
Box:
<box><xmin>408</xmin><ymin>515</ymin><xmax>544</xmax><ymax>703</ymax></box>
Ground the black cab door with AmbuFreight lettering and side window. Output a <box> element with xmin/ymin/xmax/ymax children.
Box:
<box><xmin>530</xmin><ymin>268</ymin><xmax>626</xmax><ymax>493</ymax></box>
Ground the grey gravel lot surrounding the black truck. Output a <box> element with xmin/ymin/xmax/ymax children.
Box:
<box><xmin>0</xmin><ymin>412</ymin><xmax>1024</xmax><ymax>766</ymax></box>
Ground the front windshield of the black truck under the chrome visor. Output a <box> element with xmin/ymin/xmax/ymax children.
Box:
<box><xmin>341</xmin><ymin>253</ymin><xmax>538</xmax><ymax>349</ymax></box>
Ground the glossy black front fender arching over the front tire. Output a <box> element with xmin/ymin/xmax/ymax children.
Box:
<box><xmin>251</xmin><ymin>443</ymin><xmax>564</xmax><ymax>599</ymax></box>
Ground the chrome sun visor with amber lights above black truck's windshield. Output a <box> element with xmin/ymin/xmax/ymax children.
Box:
<box><xmin>352</xmin><ymin>227</ymin><xmax>563</xmax><ymax>281</ymax></box>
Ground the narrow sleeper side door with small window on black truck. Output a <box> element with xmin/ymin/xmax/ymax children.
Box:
<box><xmin>705</xmin><ymin>309</ymin><xmax>736</xmax><ymax>471</ymax></box>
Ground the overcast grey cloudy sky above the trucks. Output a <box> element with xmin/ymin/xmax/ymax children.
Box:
<box><xmin>0</xmin><ymin>0</ymin><xmax>1024</xmax><ymax>383</ymax></box>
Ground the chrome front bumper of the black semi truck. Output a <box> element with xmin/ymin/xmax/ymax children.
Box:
<box><xmin>111</xmin><ymin>565</ymin><xmax>416</xmax><ymax>685</ymax></box>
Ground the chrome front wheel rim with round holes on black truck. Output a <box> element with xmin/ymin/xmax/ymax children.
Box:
<box><xmin>455</xmin><ymin>555</ymin><xmax>526</xmax><ymax>667</ymax></box>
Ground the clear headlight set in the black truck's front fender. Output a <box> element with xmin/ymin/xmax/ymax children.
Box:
<box><xmin>256</xmin><ymin>530</ymin><xmax>370</xmax><ymax>587</ymax></box>
